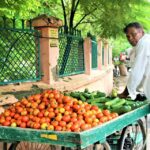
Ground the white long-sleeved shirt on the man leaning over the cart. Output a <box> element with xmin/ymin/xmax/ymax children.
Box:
<box><xmin>127</xmin><ymin>34</ymin><xmax>150</xmax><ymax>99</ymax></box>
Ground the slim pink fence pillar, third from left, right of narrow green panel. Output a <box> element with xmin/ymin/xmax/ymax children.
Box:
<box><xmin>97</xmin><ymin>39</ymin><xmax>102</xmax><ymax>70</ymax></box>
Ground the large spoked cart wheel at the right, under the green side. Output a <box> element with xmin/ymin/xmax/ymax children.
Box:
<box><xmin>119</xmin><ymin>120</ymin><xmax>146</xmax><ymax>150</ymax></box>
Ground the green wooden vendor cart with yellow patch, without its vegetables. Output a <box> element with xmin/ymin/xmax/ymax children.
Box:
<box><xmin>0</xmin><ymin>104</ymin><xmax>150</xmax><ymax>150</ymax></box>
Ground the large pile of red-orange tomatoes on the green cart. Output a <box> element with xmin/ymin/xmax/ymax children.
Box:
<box><xmin>0</xmin><ymin>90</ymin><xmax>118</xmax><ymax>132</ymax></box>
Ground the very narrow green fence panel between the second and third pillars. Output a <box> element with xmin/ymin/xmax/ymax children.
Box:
<box><xmin>92</xmin><ymin>39</ymin><xmax>97</xmax><ymax>69</ymax></box>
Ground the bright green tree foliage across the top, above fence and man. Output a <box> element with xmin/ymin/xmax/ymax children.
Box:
<box><xmin>0</xmin><ymin>0</ymin><xmax>150</xmax><ymax>59</ymax></box>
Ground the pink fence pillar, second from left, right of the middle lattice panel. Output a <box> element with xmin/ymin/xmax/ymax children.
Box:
<box><xmin>84</xmin><ymin>38</ymin><xmax>92</xmax><ymax>75</ymax></box>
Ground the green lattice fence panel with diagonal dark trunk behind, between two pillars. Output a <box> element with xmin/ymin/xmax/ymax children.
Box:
<box><xmin>58</xmin><ymin>27</ymin><xmax>85</xmax><ymax>77</ymax></box>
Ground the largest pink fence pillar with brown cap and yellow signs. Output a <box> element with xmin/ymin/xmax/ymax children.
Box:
<box><xmin>32</xmin><ymin>15</ymin><xmax>62</xmax><ymax>84</ymax></box>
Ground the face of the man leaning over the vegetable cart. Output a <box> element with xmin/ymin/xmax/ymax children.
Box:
<box><xmin>126</xmin><ymin>27</ymin><xmax>144</xmax><ymax>46</ymax></box>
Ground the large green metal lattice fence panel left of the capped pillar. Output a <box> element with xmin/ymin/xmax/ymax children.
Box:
<box><xmin>0</xmin><ymin>17</ymin><xmax>41</xmax><ymax>85</ymax></box>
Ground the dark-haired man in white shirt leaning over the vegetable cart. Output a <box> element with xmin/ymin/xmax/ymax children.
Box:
<box><xmin>119</xmin><ymin>22</ymin><xmax>150</xmax><ymax>99</ymax></box>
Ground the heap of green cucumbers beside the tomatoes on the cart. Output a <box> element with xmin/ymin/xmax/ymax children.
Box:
<box><xmin>67</xmin><ymin>89</ymin><xmax>148</xmax><ymax>114</ymax></box>
